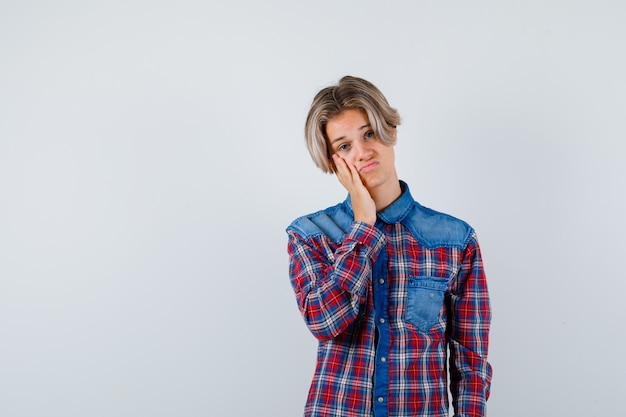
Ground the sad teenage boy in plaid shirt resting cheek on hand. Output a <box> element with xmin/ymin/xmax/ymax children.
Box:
<box><xmin>287</xmin><ymin>76</ymin><xmax>491</xmax><ymax>417</ymax></box>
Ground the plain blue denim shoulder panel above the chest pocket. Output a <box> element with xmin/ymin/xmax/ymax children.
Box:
<box><xmin>402</xmin><ymin>202</ymin><xmax>474</xmax><ymax>248</ymax></box>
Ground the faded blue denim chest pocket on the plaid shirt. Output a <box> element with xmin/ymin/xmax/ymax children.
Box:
<box><xmin>405</xmin><ymin>276</ymin><xmax>448</xmax><ymax>332</ymax></box>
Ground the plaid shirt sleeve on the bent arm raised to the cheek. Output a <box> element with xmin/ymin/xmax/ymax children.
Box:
<box><xmin>287</xmin><ymin>222</ymin><xmax>385</xmax><ymax>340</ymax></box>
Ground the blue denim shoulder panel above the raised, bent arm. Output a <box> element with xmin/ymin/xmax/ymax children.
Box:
<box><xmin>287</xmin><ymin>203</ymin><xmax>353</xmax><ymax>243</ymax></box>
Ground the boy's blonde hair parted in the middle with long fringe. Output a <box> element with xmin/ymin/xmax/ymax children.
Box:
<box><xmin>304</xmin><ymin>75</ymin><xmax>400</xmax><ymax>173</ymax></box>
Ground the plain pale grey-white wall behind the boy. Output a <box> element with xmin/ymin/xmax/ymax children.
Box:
<box><xmin>0</xmin><ymin>0</ymin><xmax>626</xmax><ymax>417</ymax></box>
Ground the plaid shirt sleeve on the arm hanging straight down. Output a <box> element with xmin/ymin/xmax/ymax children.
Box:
<box><xmin>449</xmin><ymin>234</ymin><xmax>492</xmax><ymax>417</ymax></box>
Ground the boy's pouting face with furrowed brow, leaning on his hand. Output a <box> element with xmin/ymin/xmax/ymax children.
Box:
<box><xmin>326</xmin><ymin>109</ymin><xmax>398</xmax><ymax>192</ymax></box>
